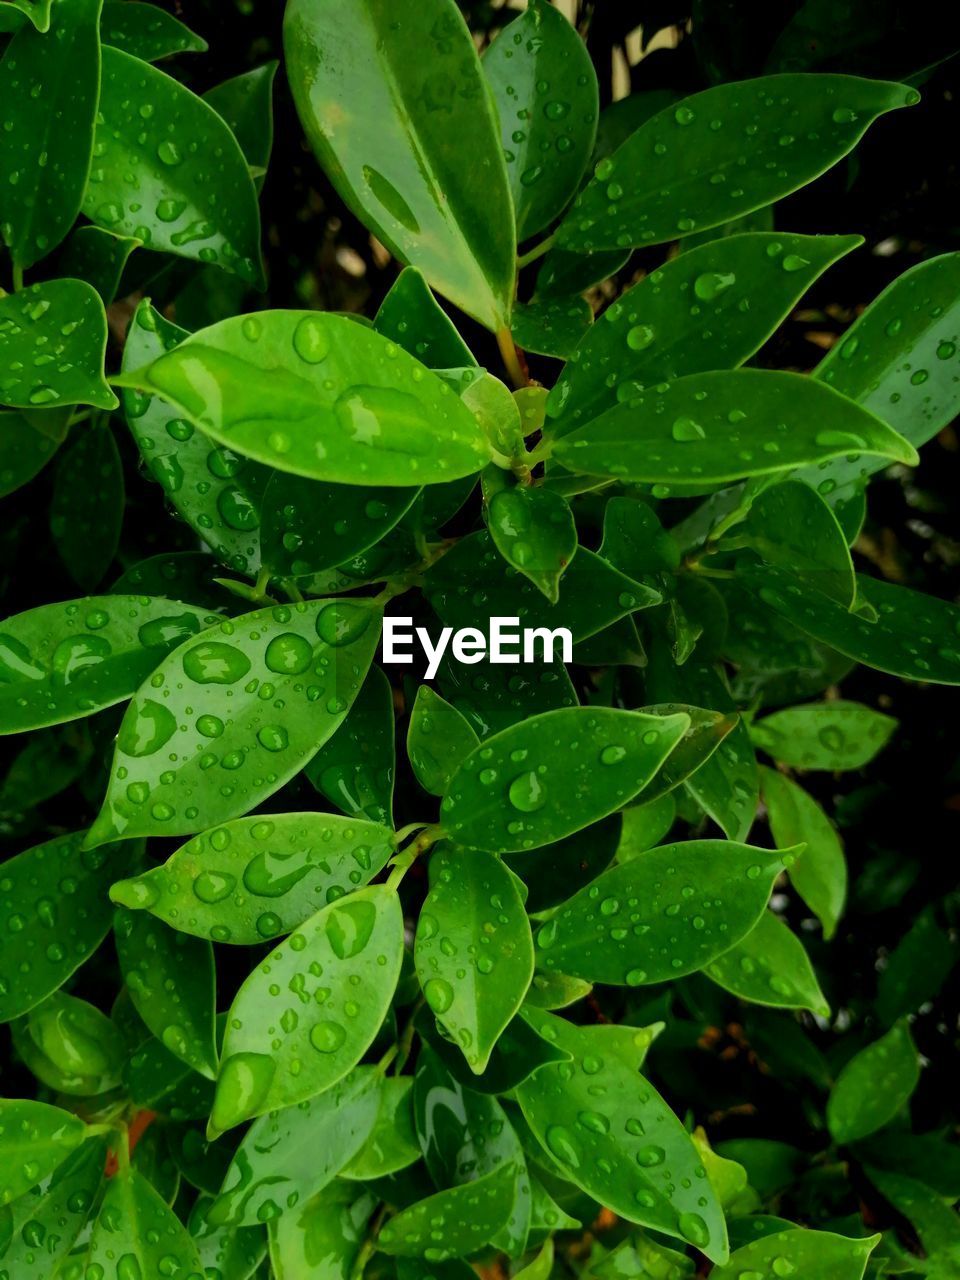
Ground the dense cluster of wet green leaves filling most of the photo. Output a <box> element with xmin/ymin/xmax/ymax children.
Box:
<box><xmin>0</xmin><ymin>0</ymin><xmax>960</xmax><ymax>1280</ymax></box>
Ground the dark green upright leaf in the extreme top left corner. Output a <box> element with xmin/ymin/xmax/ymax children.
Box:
<box><xmin>0</xmin><ymin>0</ymin><xmax>101</xmax><ymax>269</ymax></box>
